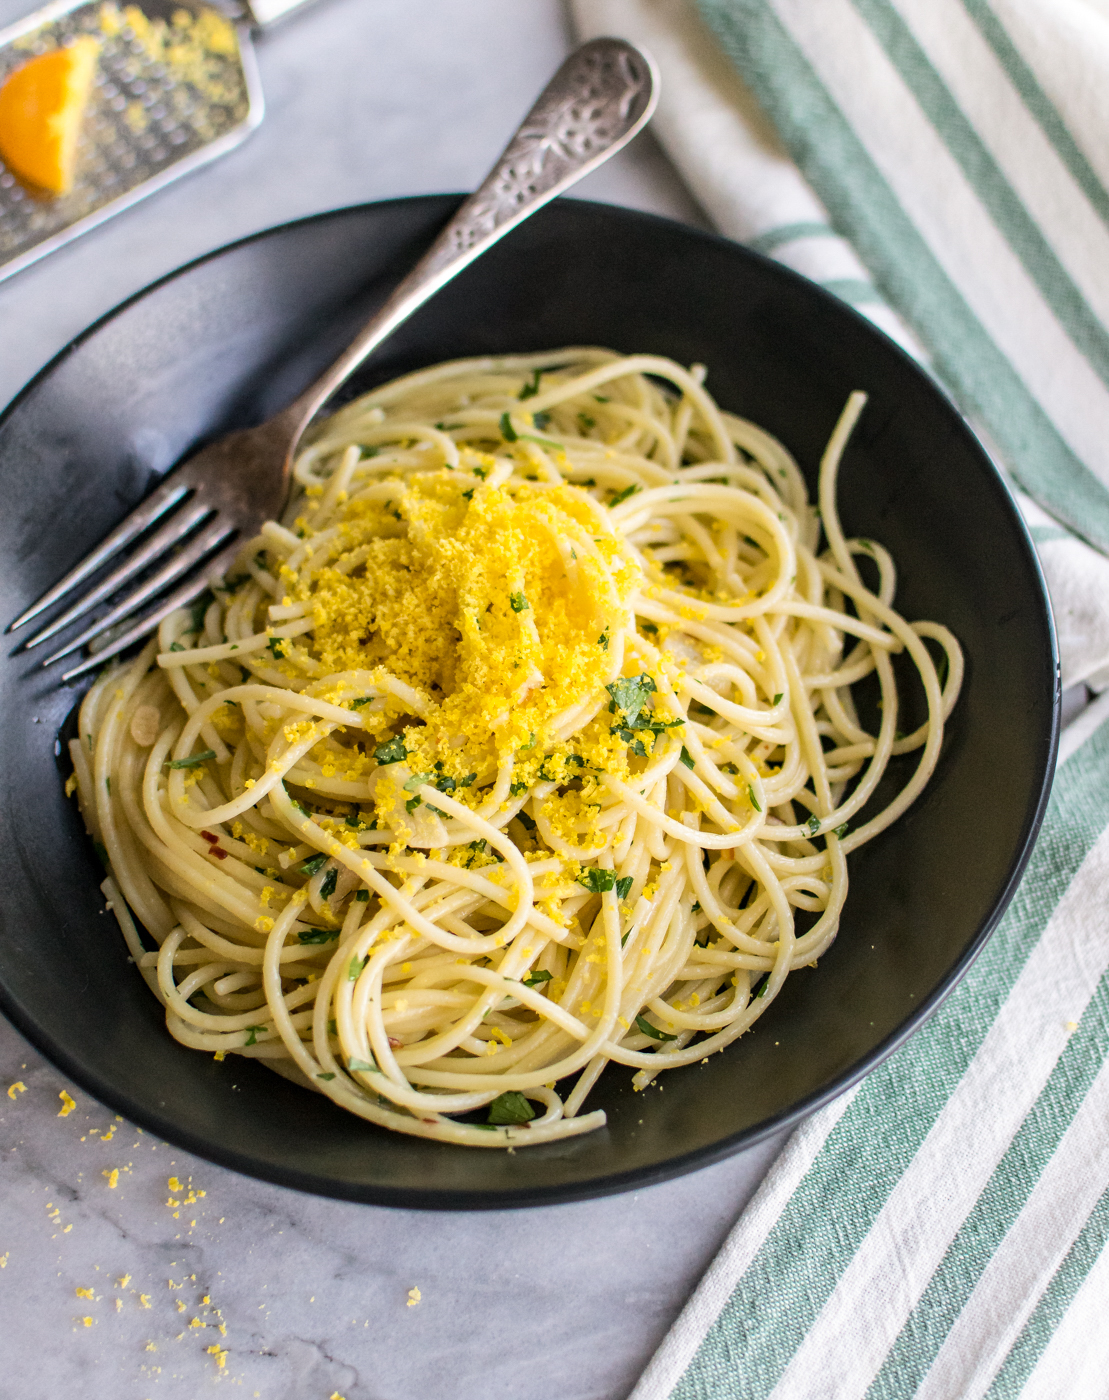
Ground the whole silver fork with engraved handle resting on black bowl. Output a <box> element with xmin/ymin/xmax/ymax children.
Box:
<box><xmin>8</xmin><ymin>39</ymin><xmax>658</xmax><ymax>680</ymax></box>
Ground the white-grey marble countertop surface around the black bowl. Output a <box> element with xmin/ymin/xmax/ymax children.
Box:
<box><xmin>0</xmin><ymin>0</ymin><xmax>779</xmax><ymax>1400</ymax></box>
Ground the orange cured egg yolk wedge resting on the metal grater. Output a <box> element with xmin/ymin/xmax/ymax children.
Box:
<box><xmin>0</xmin><ymin>36</ymin><xmax>99</xmax><ymax>195</ymax></box>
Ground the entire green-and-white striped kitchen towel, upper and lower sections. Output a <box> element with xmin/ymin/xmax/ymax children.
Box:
<box><xmin>571</xmin><ymin>0</ymin><xmax>1109</xmax><ymax>1400</ymax></box>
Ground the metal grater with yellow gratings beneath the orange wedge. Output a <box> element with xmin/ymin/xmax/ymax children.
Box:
<box><xmin>0</xmin><ymin>0</ymin><xmax>307</xmax><ymax>279</ymax></box>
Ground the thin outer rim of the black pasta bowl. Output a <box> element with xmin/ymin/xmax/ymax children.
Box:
<box><xmin>0</xmin><ymin>193</ymin><xmax>1061</xmax><ymax>1211</ymax></box>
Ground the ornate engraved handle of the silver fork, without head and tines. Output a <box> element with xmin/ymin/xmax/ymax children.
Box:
<box><xmin>279</xmin><ymin>39</ymin><xmax>658</xmax><ymax>426</ymax></box>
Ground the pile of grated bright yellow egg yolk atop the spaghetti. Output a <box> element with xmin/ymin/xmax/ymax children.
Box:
<box><xmin>284</xmin><ymin>470</ymin><xmax>641</xmax><ymax>778</ymax></box>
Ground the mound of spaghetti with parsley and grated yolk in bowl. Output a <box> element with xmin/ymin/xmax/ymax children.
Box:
<box><xmin>71</xmin><ymin>349</ymin><xmax>962</xmax><ymax>1147</ymax></box>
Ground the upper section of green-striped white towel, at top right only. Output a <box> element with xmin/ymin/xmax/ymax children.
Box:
<box><xmin>571</xmin><ymin>0</ymin><xmax>1109</xmax><ymax>690</ymax></box>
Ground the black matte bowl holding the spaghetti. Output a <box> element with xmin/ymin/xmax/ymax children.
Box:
<box><xmin>0</xmin><ymin>197</ymin><xmax>1059</xmax><ymax>1208</ymax></box>
